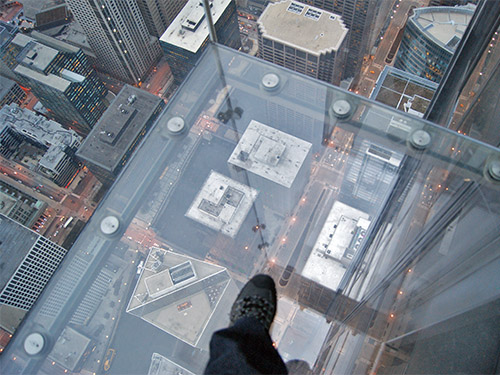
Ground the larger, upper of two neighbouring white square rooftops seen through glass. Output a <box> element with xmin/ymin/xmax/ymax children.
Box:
<box><xmin>228</xmin><ymin>120</ymin><xmax>312</xmax><ymax>188</ymax></box>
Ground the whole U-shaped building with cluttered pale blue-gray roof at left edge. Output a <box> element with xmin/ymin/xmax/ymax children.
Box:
<box><xmin>0</xmin><ymin>104</ymin><xmax>82</xmax><ymax>186</ymax></box>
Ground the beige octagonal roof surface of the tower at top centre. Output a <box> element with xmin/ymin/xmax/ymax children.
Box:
<box><xmin>257</xmin><ymin>0</ymin><xmax>348</xmax><ymax>56</ymax></box>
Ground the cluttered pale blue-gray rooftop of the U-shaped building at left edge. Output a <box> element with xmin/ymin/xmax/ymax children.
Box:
<box><xmin>0</xmin><ymin>103</ymin><xmax>82</xmax><ymax>169</ymax></box>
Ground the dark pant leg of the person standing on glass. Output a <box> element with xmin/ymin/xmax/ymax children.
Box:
<box><xmin>205</xmin><ymin>318</ymin><xmax>287</xmax><ymax>374</ymax></box>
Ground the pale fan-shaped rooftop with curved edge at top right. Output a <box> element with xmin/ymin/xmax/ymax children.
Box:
<box><xmin>410</xmin><ymin>4</ymin><xmax>475</xmax><ymax>53</ymax></box>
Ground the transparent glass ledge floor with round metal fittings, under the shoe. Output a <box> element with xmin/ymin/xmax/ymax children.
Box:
<box><xmin>0</xmin><ymin>45</ymin><xmax>500</xmax><ymax>374</ymax></box>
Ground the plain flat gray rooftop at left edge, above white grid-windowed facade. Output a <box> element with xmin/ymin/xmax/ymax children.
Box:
<box><xmin>0</xmin><ymin>215</ymin><xmax>40</xmax><ymax>291</ymax></box>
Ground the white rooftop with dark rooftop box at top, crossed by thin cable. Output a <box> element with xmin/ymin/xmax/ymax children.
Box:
<box><xmin>160</xmin><ymin>0</ymin><xmax>233</xmax><ymax>53</ymax></box>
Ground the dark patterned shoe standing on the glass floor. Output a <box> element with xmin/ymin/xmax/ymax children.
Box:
<box><xmin>229</xmin><ymin>274</ymin><xmax>276</xmax><ymax>331</ymax></box>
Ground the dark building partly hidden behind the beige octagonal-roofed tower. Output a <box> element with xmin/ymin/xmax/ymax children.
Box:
<box><xmin>299</xmin><ymin>0</ymin><xmax>380</xmax><ymax>79</ymax></box>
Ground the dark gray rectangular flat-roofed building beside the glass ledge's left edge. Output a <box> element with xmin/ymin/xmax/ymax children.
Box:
<box><xmin>76</xmin><ymin>85</ymin><xmax>165</xmax><ymax>186</ymax></box>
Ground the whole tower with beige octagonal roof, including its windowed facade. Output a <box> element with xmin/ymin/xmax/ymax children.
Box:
<box><xmin>258</xmin><ymin>0</ymin><xmax>348</xmax><ymax>84</ymax></box>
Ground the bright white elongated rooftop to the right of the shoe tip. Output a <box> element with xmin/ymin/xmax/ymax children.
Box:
<box><xmin>302</xmin><ymin>201</ymin><xmax>370</xmax><ymax>290</ymax></box>
